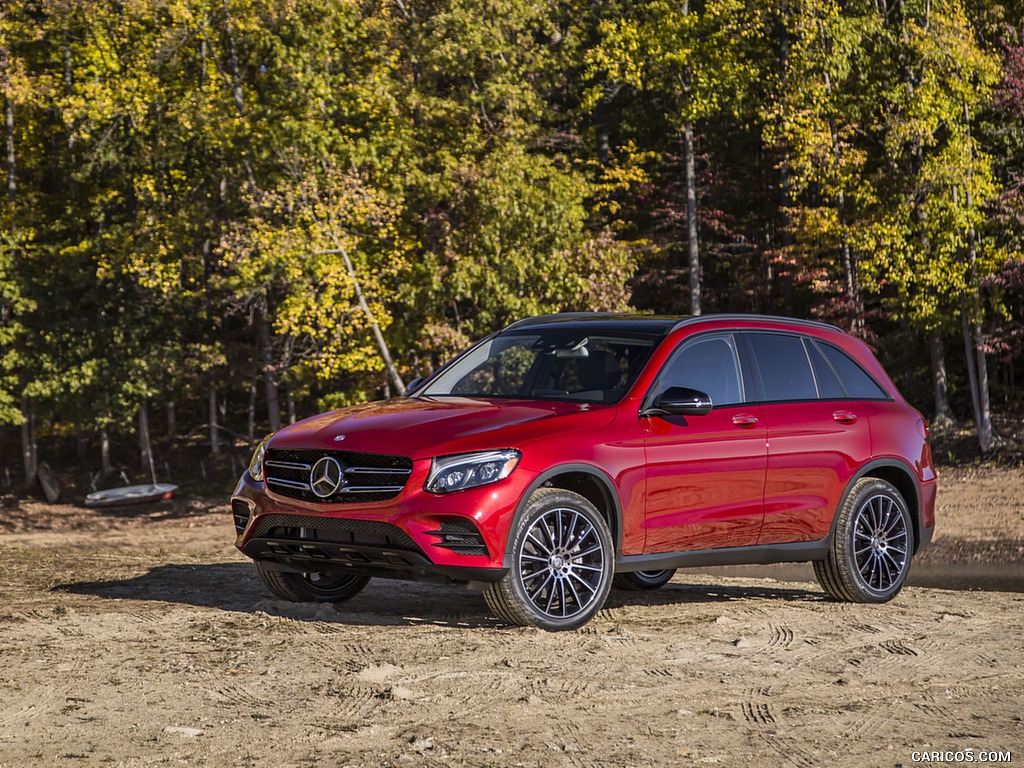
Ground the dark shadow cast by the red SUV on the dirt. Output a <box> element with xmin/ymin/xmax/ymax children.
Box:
<box><xmin>52</xmin><ymin>562</ymin><xmax>824</xmax><ymax>628</ymax></box>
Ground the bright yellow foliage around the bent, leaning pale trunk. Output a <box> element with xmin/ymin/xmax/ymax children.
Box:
<box><xmin>222</xmin><ymin>162</ymin><xmax>406</xmax><ymax>389</ymax></box>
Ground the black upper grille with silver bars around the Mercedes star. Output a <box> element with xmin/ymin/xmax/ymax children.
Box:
<box><xmin>263</xmin><ymin>449</ymin><xmax>413</xmax><ymax>504</ymax></box>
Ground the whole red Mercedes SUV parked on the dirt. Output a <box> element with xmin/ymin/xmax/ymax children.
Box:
<box><xmin>231</xmin><ymin>314</ymin><xmax>936</xmax><ymax>630</ymax></box>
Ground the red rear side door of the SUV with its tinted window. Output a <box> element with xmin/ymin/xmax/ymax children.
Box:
<box><xmin>742</xmin><ymin>332</ymin><xmax>871</xmax><ymax>545</ymax></box>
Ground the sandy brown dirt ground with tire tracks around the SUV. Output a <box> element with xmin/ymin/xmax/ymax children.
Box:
<box><xmin>0</xmin><ymin>469</ymin><xmax>1024</xmax><ymax>768</ymax></box>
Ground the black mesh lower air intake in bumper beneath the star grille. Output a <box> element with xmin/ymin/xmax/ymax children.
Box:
<box><xmin>249</xmin><ymin>515</ymin><xmax>422</xmax><ymax>552</ymax></box>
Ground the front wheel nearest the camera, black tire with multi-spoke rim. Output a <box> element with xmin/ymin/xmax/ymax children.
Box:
<box><xmin>483</xmin><ymin>488</ymin><xmax>615</xmax><ymax>632</ymax></box>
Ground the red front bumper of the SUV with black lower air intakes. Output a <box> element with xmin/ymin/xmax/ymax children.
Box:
<box><xmin>231</xmin><ymin>461</ymin><xmax>536</xmax><ymax>583</ymax></box>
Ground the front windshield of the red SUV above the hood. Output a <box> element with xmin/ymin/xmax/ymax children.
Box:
<box><xmin>417</xmin><ymin>329</ymin><xmax>654</xmax><ymax>402</ymax></box>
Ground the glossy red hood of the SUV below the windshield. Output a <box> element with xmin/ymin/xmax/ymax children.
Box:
<box><xmin>268</xmin><ymin>397</ymin><xmax>615</xmax><ymax>460</ymax></box>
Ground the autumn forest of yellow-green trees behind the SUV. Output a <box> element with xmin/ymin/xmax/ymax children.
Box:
<box><xmin>0</xmin><ymin>0</ymin><xmax>1024</xmax><ymax>485</ymax></box>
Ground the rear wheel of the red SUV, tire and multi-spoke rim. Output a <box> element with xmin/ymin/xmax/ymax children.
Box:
<box><xmin>814</xmin><ymin>477</ymin><xmax>913</xmax><ymax>603</ymax></box>
